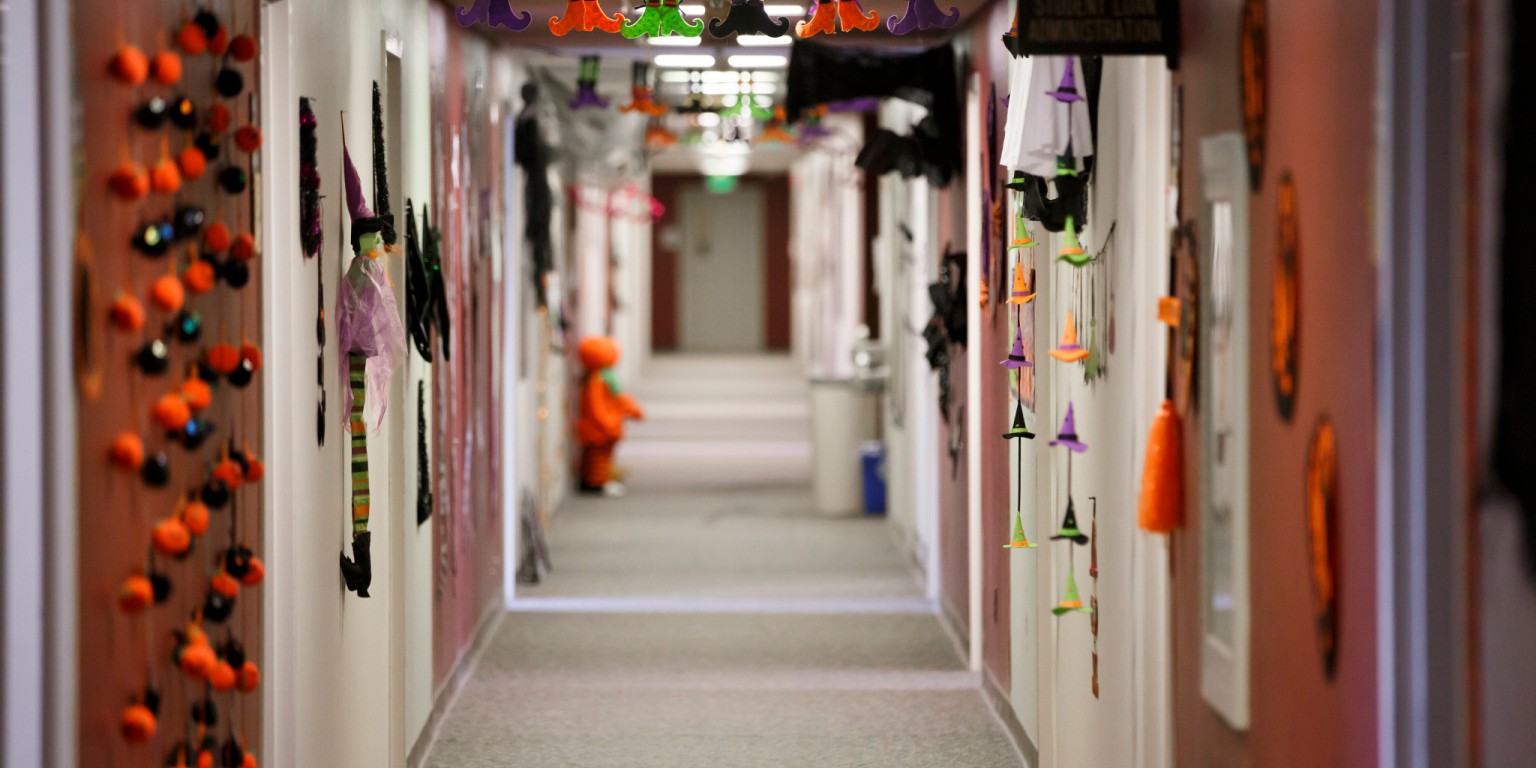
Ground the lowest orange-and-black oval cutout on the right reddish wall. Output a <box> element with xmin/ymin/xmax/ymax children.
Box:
<box><xmin>1306</xmin><ymin>415</ymin><xmax>1339</xmax><ymax>679</ymax></box>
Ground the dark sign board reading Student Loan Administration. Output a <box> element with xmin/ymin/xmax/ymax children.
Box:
<box><xmin>1015</xmin><ymin>0</ymin><xmax>1178</xmax><ymax>69</ymax></box>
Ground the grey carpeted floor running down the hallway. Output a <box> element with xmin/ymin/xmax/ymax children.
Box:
<box><xmin>427</xmin><ymin>358</ymin><xmax>1020</xmax><ymax>768</ymax></box>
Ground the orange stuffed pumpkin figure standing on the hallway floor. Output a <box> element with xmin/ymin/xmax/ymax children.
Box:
<box><xmin>576</xmin><ymin>336</ymin><xmax>645</xmax><ymax>496</ymax></box>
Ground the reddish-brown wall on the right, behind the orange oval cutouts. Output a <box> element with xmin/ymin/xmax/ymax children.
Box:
<box><xmin>1172</xmin><ymin>0</ymin><xmax>1376</xmax><ymax>768</ymax></box>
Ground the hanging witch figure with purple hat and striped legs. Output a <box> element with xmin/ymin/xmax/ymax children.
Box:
<box><xmin>336</xmin><ymin>115</ymin><xmax>406</xmax><ymax>598</ymax></box>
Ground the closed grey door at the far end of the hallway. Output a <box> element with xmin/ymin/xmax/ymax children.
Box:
<box><xmin>677</xmin><ymin>184</ymin><xmax>765</xmax><ymax>352</ymax></box>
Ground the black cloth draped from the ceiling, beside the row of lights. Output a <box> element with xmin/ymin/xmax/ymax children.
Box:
<box><xmin>783</xmin><ymin>41</ymin><xmax>965</xmax><ymax>183</ymax></box>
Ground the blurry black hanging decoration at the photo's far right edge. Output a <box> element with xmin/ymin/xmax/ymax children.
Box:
<box><xmin>1493</xmin><ymin>3</ymin><xmax>1536</xmax><ymax>578</ymax></box>
